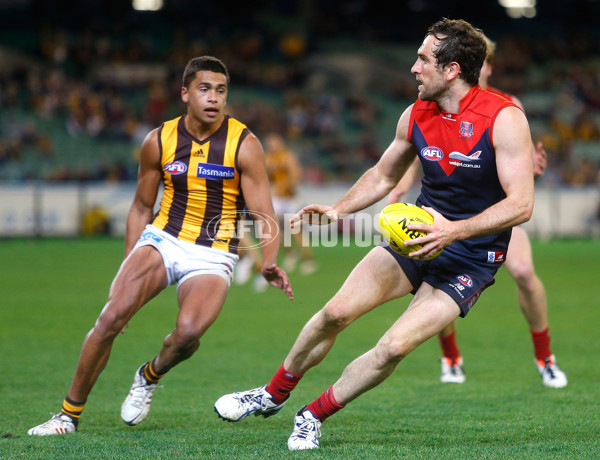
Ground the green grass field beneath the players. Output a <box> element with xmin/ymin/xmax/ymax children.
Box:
<box><xmin>0</xmin><ymin>239</ymin><xmax>600</xmax><ymax>459</ymax></box>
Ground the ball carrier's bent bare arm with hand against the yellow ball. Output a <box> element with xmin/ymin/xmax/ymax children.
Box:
<box><xmin>407</xmin><ymin>107</ymin><xmax>533</xmax><ymax>258</ymax></box>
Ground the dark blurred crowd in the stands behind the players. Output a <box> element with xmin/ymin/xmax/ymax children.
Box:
<box><xmin>0</xmin><ymin>0</ymin><xmax>600</xmax><ymax>186</ymax></box>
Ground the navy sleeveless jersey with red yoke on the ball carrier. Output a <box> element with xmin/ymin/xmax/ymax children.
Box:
<box><xmin>408</xmin><ymin>86</ymin><xmax>515</xmax><ymax>263</ymax></box>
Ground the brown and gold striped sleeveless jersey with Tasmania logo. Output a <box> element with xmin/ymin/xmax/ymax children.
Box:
<box><xmin>152</xmin><ymin>115</ymin><xmax>250</xmax><ymax>254</ymax></box>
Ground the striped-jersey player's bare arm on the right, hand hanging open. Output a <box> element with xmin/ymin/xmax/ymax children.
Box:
<box><xmin>238</xmin><ymin>134</ymin><xmax>294</xmax><ymax>299</ymax></box>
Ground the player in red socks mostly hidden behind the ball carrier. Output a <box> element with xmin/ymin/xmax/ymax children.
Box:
<box><xmin>389</xmin><ymin>37</ymin><xmax>567</xmax><ymax>388</ymax></box>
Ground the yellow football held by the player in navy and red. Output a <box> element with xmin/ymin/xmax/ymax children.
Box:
<box><xmin>379</xmin><ymin>203</ymin><xmax>442</xmax><ymax>259</ymax></box>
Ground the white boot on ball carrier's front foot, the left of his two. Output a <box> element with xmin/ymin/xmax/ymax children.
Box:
<box><xmin>215</xmin><ymin>385</ymin><xmax>287</xmax><ymax>422</ymax></box>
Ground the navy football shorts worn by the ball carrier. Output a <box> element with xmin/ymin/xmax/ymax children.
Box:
<box><xmin>378</xmin><ymin>241</ymin><xmax>501</xmax><ymax>318</ymax></box>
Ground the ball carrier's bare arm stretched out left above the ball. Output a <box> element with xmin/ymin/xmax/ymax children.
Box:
<box><xmin>291</xmin><ymin>105</ymin><xmax>415</xmax><ymax>227</ymax></box>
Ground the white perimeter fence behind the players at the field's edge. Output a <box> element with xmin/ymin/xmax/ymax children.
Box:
<box><xmin>0</xmin><ymin>183</ymin><xmax>600</xmax><ymax>239</ymax></box>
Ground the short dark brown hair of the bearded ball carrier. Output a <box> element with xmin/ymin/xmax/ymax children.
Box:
<box><xmin>427</xmin><ymin>18</ymin><xmax>487</xmax><ymax>86</ymax></box>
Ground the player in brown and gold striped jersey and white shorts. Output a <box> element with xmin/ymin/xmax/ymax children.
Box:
<box><xmin>28</xmin><ymin>56</ymin><xmax>293</xmax><ymax>436</ymax></box>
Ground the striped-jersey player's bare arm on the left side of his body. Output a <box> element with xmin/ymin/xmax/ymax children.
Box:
<box><xmin>125</xmin><ymin>129</ymin><xmax>162</xmax><ymax>257</ymax></box>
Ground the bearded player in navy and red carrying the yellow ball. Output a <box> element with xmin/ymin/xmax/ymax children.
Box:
<box><xmin>215</xmin><ymin>19</ymin><xmax>533</xmax><ymax>450</ymax></box>
